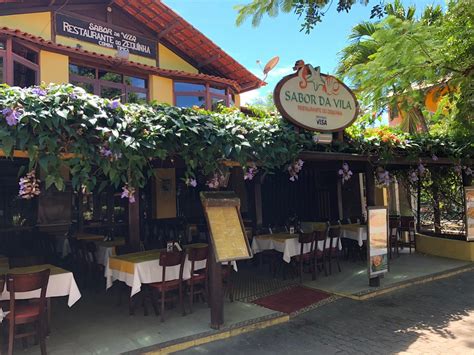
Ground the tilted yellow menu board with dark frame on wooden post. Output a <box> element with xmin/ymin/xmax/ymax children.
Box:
<box><xmin>201</xmin><ymin>192</ymin><xmax>252</xmax><ymax>262</ymax></box>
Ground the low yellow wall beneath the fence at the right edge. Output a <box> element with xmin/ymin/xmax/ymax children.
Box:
<box><xmin>416</xmin><ymin>234</ymin><xmax>474</xmax><ymax>261</ymax></box>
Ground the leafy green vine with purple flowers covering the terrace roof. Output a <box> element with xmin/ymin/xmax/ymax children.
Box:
<box><xmin>0</xmin><ymin>84</ymin><xmax>474</xmax><ymax>200</ymax></box>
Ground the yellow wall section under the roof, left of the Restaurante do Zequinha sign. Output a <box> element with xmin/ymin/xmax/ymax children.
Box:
<box><xmin>0</xmin><ymin>12</ymin><xmax>51</xmax><ymax>41</ymax></box>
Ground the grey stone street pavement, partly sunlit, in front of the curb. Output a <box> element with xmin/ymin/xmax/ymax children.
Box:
<box><xmin>180</xmin><ymin>271</ymin><xmax>474</xmax><ymax>355</ymax></box>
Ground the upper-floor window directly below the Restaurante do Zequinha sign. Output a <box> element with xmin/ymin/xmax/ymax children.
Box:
<box><xmin>69</xmin><ymin>64</ymin><xmax>148</xmax><ymax>103</ymax></box>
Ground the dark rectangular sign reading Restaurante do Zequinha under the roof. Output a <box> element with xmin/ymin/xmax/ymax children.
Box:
<box><xmin>56</xmin><ymin>14</ymin><xmax>156</xmax><ymax>58</ymax></box>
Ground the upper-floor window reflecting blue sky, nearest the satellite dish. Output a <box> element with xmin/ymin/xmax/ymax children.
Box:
<box><xmin>174</xmin><ymin>82</ymin><xmax>233</xmax><ymax>110</ymax></box>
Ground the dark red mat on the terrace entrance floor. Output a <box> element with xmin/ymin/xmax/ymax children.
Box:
<box><xmin>253</xmin><ymin>286</ymin><xmax>331</xmax><ymax>314</ymax></box>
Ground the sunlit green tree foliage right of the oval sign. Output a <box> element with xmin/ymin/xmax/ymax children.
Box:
<box><xmin>337</xmin><ymin>0</ymin><xmax>474</xmax><ymax>139</ymax></box>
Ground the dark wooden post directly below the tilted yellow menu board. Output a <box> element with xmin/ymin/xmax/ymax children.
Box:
<box><xmin>208</xmin><ymin>243</ymin><xmax>224</xmax><ymax>329</ymax></box>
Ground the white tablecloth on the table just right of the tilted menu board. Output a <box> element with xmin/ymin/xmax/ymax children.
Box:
<box><xmin>252</xmin><ymin>234</ymin><xmax>342</xmax><ymax>263</ymax></box>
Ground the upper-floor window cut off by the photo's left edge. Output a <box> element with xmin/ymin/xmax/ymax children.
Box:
<box><xmin>0</xmin><ymin>38</ymin><xmax>39</xmax><ymax>87</ymax></box>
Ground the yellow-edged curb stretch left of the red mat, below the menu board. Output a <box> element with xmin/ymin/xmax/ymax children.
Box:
<box><xmin>123</xmin><ymin>313</ymin><xmax>290</xmax><ymax>355</ymax></box>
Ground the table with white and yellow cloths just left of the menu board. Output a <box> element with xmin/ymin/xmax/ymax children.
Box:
<box><xmin>104</xmin><ymin>243</ymin><xmax>207</xmax><ymax>297</ymax></box>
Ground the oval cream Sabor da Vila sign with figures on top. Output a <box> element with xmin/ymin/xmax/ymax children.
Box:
<box><xmin>273</xmin><ymin>60</ymin><xmax>359</xmax><ymax>132</ymax></box>
